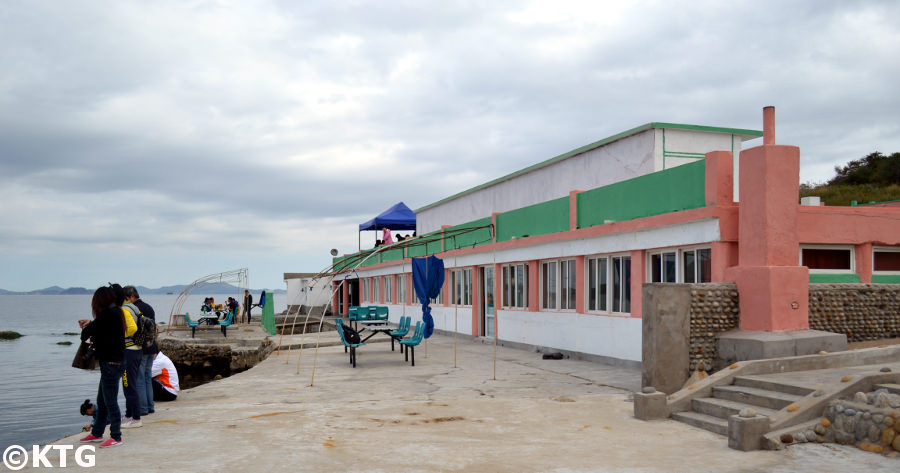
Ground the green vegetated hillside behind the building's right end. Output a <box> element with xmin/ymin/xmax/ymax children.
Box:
<box><xmin>800</xmin><ymin>151</ymin><xmax>900</xmax><ymax>205</ymax></box>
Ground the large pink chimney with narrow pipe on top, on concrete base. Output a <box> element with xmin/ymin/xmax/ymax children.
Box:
<box><xmin>725</xmin><ymin>107</ymin><xmax>809</xmax><ymax>331</ymax></box>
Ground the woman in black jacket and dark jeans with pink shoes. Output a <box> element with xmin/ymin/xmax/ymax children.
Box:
<box><xmin>78</xmin><ymin>286</ymin><xmax>125</xmax><ymax>447</ymax></box>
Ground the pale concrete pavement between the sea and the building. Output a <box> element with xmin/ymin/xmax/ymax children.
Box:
<box><xmin>44</xmin><ymin>332</ymin><xmax>900</xmax><ymax>473</ymax></box>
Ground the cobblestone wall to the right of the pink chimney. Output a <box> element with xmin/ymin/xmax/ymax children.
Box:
<box><xmin>809</xmin><ymin>284</ymin><xmax>900</xmax><ymax>342</ymax></box>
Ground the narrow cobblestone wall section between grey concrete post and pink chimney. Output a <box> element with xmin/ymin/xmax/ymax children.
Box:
<box><xmin>690</xmin><ymin>283</ymin><xmax>741</xmax><ymax>372</ymax></box>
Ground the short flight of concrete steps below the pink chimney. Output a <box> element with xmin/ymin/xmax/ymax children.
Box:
<box><xmin>672</xmin><ymin>376</ymin><xmax>813</xmax><ymax>435</ymax></box>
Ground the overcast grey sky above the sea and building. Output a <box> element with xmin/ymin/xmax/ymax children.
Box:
<box><xmin>0</xmin><ymin>0</ymin><xmax>900</xmax><ymax>290</ymax></box>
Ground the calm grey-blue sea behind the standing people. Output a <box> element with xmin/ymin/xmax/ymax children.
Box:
<box><xmin>0</xmin><ymin>294</ymin><xmax>286</xmax><ymax>451</ymax></box>
